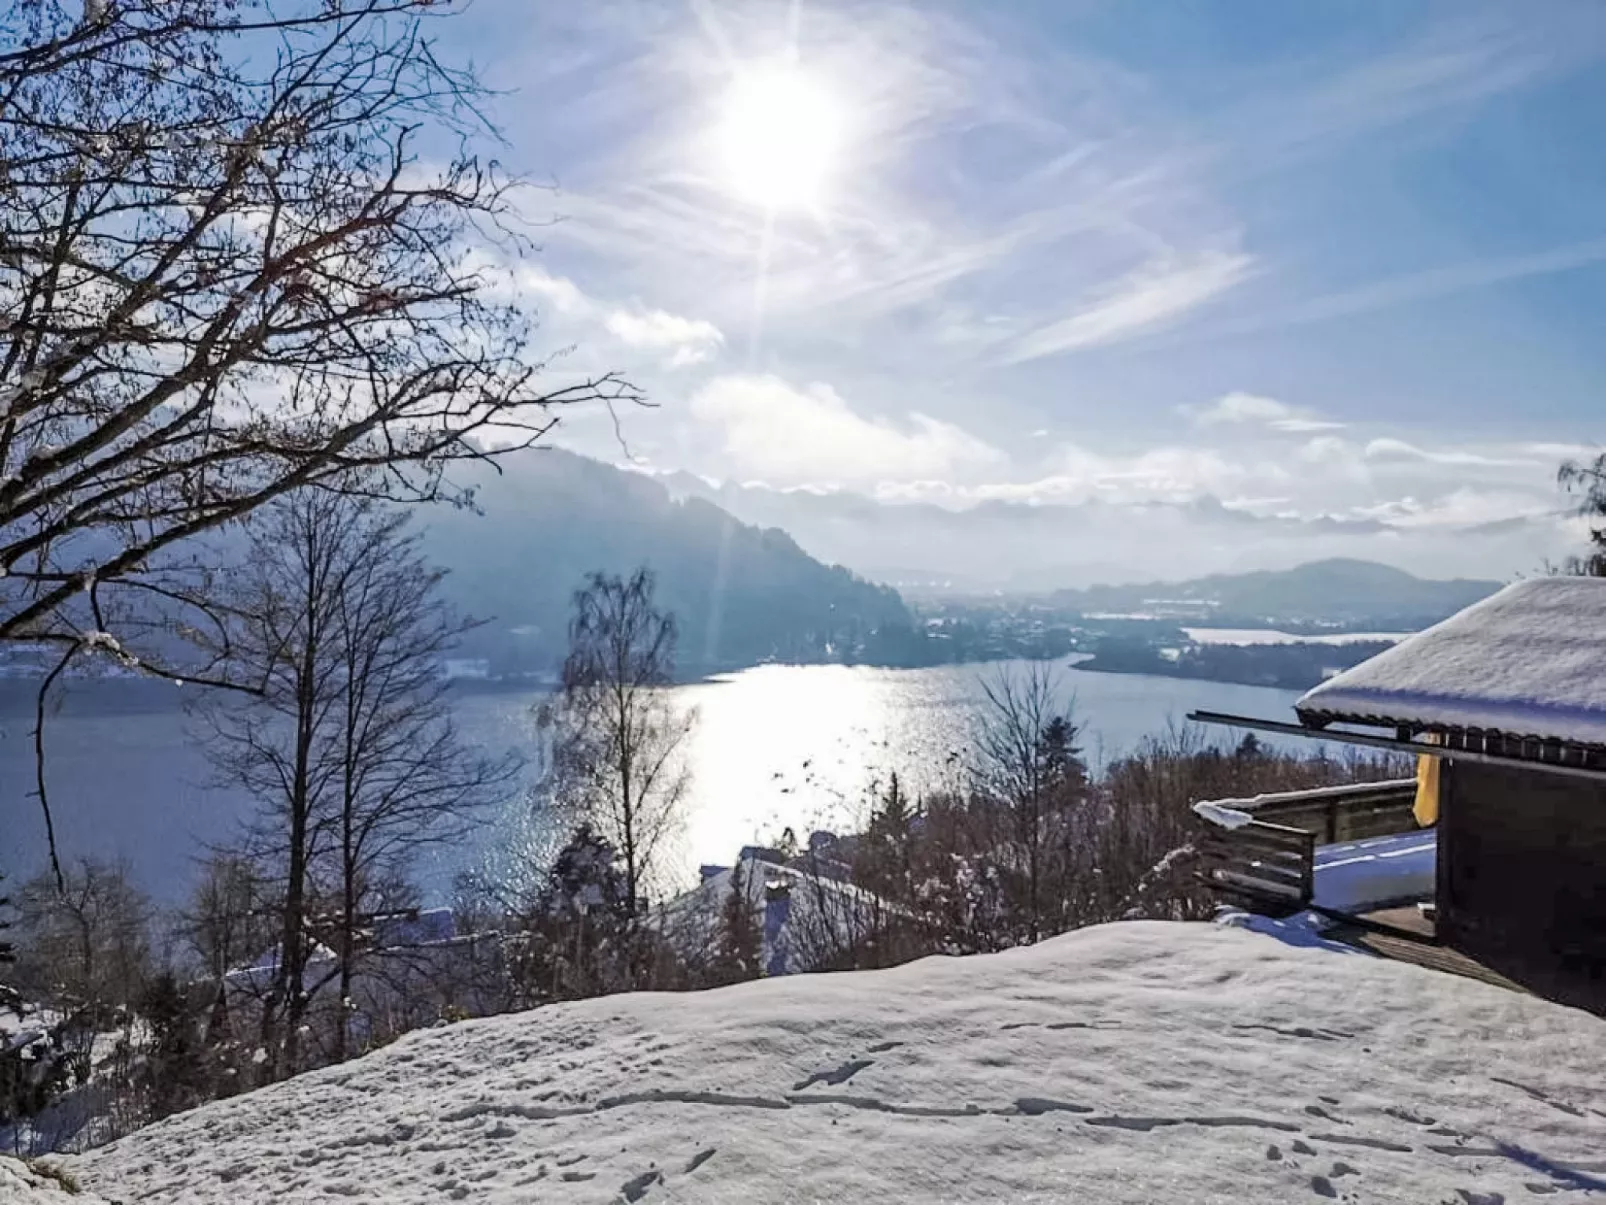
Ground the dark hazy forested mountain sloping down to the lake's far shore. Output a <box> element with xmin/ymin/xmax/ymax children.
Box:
<box><xmin>424</xmin><ymin>448</ymin><xmax>914</xmax><ymax>673</ymax></box>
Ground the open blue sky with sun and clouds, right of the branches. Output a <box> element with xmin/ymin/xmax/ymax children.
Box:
<box><xmin>442</xmin><ymin>0</ymin><xmax>1606</xmax><ymax>577</ymax></box>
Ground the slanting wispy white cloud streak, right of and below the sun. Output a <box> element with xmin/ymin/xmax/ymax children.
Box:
<box><xmin>1005</xmin><ymin>251</ymin><xmax>1253</xmax><ymax>363</ymax></box>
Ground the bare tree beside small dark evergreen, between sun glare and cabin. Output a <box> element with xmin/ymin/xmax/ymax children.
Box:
<box><xmin>975</xmin><ymin>662</ymin><xmax>1087</xmax><ymax>942</ymax></box>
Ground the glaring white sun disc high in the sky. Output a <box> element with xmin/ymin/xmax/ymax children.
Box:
<box><xmin>715</xmin><ymin>63</ymin><xmax>843</xmax><ymax>210</ymax></box>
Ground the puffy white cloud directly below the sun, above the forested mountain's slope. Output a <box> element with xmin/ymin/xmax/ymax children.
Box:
<box><xmin>691</xmin><ymin>374</ymin><xmax>1004</xmax><ymax>485</ymax></box>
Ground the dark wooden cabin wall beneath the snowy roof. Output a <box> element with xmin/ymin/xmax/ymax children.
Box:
<box><xmin>1437</xmin><ymin>762</ymin><xmax>1606</xmax><ymax>1009</ymax></box>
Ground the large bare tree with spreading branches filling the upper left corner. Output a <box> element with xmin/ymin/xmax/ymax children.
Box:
<box><xmin>0</xmin><ymin>0</ymin><xmax>636</xmax><ymax>879</ymax></box>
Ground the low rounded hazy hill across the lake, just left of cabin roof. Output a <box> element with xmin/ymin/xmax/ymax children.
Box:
<box><xmin>1052</xmin><ymin>558</ymin><xmax>1502</xmax><ymax>631</ymax></box>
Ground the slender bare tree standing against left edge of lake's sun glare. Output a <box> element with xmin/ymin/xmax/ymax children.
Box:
<box><xmin>543</xmin><ymin>569</ymin><xmax>695</xmax><ymax>921</ymax></box>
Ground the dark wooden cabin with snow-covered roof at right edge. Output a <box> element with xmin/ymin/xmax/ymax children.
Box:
<box><xmin>1198</xmin><ymin>578</ymin><xmax>1606</xmax><ymax>1011</ymax></box>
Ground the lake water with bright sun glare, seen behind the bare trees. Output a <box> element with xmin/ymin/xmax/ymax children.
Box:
<box><xmin>0</xmin><ymin>664</ymin><xmax>1304</xmax><ymax>903</ymax></box>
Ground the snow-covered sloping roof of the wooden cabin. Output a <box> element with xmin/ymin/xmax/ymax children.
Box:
<box><xmin>1294</xmin><ymin>577</ymin><xmax>1606</xmax><ymax>745</ymax></box>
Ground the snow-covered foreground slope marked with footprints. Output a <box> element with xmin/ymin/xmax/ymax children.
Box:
<box><xmin>69</xmin><ymin>922</ymin><xmax>1606</xmax><ymax>1205</ymax></box>
